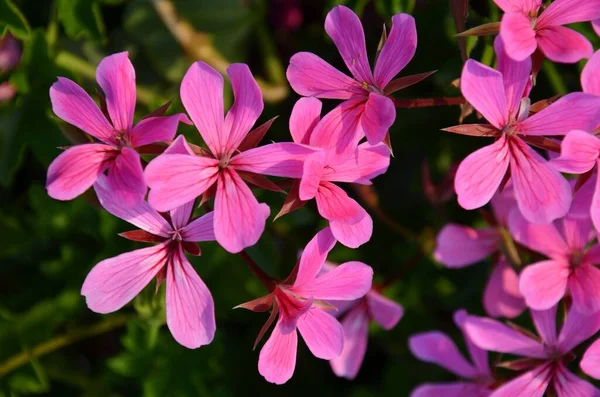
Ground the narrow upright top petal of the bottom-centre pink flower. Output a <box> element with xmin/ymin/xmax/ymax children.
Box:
<box><xmin>294</xmin><ymin>228</ymin><xmax>335</xmax><ymax>288</ymax></box>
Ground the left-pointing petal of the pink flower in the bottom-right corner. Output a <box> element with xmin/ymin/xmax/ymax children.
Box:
<box><xmin>464</xmin><ymin>316</ymin><xmax>546</xmax><ymax>358</ymax></box>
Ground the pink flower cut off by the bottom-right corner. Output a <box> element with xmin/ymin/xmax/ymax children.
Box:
<box><xmin>465</xmin><ymin>306</ymin><xmax>600</xmax><ymax>397</ymax></box>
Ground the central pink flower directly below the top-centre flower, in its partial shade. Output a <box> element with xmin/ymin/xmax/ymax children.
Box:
<box><xmin>290</xmin><ymin>98</ymin><xmax>390</xmax><ymax>248</ymax></box>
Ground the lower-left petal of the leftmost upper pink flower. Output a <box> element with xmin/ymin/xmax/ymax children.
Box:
<box><xmin>46</xmin><ymin>143</ymin><xmax>118</xmax><ymax>200</ymax></box>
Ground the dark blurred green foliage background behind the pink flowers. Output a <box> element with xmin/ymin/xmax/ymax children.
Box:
<box><xmin>0</xmin><ymin>0</ymin><xmax>600</xmax><ymax>396</ymax></box>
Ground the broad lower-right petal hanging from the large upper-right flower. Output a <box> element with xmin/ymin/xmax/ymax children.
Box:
<box><xmin>509</xmin><ymin>138</ymin><xmax>572</xmax><ymax>223</ymax></box>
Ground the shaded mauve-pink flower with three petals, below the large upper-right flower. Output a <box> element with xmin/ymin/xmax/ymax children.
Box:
<box><xmin>433</xmin><ymin>191</ymin><xmax>526</xmax><ymax>318</ymax></box>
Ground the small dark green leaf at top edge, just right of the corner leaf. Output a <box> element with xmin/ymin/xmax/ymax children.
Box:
<box><xmin>57</xmin><ymin>0</ymin><xmax>105</xmax><ymax>41</ymax></box>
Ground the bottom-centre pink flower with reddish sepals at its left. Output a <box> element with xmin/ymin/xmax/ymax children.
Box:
<box><xmin>239</xmin><ymin>228</ymin><xmax>373</xmax><ymax>384</ymax></box>
